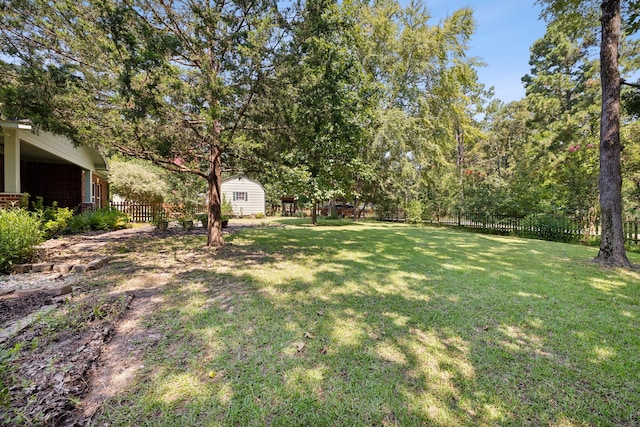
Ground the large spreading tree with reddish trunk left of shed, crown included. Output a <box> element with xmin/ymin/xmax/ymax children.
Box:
<box><xmin>0</xmin><ymin>0</ymin><xmax>283</xmax><ymax>245</ymax></box>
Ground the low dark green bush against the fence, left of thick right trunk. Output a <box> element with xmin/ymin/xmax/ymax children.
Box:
<box><xmin>518</xmin><ymin>213</ymin><xmax>581</xmax><ymax>242</ymax></box>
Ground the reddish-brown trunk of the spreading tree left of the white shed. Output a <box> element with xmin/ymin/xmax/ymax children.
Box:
<box><xmin>207</xmin><ymin>144</ymin><xmax>224</xmax><ymax>246</ymax></box>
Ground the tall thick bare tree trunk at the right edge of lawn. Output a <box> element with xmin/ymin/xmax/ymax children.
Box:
<box><xmin>596</xmin><ymin>0</ymin><xmax>630</xmax><ymax>267</ymax></box>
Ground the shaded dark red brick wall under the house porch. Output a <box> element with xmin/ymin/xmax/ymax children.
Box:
<box><xmin>20</xmin><ymin>162</ymin><xmax>83</xmax><ymax>208</ymax></box>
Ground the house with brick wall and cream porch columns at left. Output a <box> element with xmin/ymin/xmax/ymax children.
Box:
<box><xmin>0</xmin><ymin>121</ymin><xmax>109</xmax><ymax>210</ymax></box>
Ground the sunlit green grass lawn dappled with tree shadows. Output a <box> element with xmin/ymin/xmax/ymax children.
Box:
<box><xmin>96</xmin><ymin>221</ymin><xmax>640</xmax><ymax>426</ymax></box>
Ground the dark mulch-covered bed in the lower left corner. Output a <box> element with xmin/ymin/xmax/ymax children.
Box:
<box><xmin>0</xmin><ymin>295</ymin><xmax>133</xmax><ymax>425</ymax></box>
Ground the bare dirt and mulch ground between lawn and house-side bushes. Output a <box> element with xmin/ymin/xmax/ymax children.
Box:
<box><xmin>0</xmin><ymin>227</ymin><xmax>248</xmax><ymax>426</ymax></box>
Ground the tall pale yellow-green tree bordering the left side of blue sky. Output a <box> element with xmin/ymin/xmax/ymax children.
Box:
<box><xmin>359</xmin><ymin>0</ymin><xmax>479</xmax><ymax>216</ymax></box>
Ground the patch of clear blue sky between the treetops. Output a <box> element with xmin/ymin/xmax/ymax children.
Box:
<box><xmin>424</xmin><ymin>0</ymin><xmax>545</xmax><ymax>102</ymax></box>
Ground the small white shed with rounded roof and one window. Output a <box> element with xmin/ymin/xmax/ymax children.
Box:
<box><xmin>222</xmin><ymin>175</ymin><xmax>265</xmax><ymax>216</ymax></box>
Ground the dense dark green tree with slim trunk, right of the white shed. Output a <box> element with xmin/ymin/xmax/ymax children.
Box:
<box><xmin>265</xmin><ymin>0</ymin><xmax>376</xmax><ymax>224</ymax></box>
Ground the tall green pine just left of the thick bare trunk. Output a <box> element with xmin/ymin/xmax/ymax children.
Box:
<box><xmin>522</xmin><ymin>22</ymin><xmax>600</xmax><ymax>218</ymax></box>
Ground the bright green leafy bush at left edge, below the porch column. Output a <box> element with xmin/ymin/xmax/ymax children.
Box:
<box><xmin>0</xmin><ymin>208</ymin><xmax>44</xmax><ymax>271</ymax></box>
